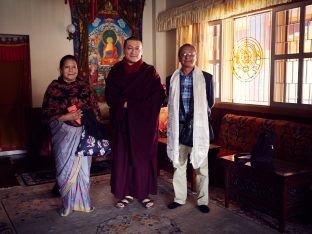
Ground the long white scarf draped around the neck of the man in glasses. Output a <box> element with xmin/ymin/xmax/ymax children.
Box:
<box><xmin>167</xmin><ymin>67</ymin><xmax>209</xmax><ymax>169</ymax></box>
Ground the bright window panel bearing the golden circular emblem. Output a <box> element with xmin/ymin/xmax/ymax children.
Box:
<box><xmin>222</xmin><ymin>12</ymin><xmax>271</xmax><ymax>105</ymax></box>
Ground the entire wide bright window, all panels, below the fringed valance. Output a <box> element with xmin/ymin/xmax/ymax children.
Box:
<box><xmin>173</xmin><ymin>1</ymin><xmax>312</xmax><ymax>108</ymax></box>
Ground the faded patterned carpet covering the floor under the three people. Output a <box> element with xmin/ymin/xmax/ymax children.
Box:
<box><xmin>0</xmin><ymin>171</ymin><xmax>312</xmax><ymax>234</ymax></box>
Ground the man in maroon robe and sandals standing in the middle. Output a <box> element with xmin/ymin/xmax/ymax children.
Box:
<box><xmin>105</xmin><ymin>37</ymin><xmax>165</xmax><ymax>208</ymax></box>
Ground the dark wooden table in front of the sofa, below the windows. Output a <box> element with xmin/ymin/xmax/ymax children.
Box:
<box><xmin>219</xmin><ymin>155</ymin><xmax>312</xmax><ymax>232</ymax></box>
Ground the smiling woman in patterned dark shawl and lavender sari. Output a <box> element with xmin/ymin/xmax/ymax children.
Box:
<box><xmin>42</xmin><ymin>55</ymin><xmax>100</xmax><ymax>216</ymax></box>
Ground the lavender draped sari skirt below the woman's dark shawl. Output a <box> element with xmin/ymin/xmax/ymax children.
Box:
<box><xmin>50</xmin><ymin>120</ymin><xmax>93</xmax><ymax>216</ymax></box>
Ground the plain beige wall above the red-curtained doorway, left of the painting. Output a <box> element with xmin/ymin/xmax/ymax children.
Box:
<box><xmin>0</xmin><ymin>0</ymin><xmax>73</xmax><ymax>107</ymax></box>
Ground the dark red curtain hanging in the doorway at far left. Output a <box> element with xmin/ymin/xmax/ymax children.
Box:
<box><xmin>0</xmin><ymin>34</ymin><xmax>32</xmax><ymax>151</ymax></box>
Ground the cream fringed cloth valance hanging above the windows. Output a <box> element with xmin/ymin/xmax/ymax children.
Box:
<box><xmin>156</xmin><ymin>0</ymin><xmax>296</xmax><ymax>32</ymax></box>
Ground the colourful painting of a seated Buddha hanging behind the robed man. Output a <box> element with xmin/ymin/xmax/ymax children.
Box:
<box><xmin>88</xmin><ymin>17</ymin><xmax>131</xmax><ymax>98</ymax></box>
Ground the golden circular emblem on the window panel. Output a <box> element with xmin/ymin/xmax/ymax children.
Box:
<box><xmin>232</xmin><ymin>37</ymin><xmax>263</xmax><ymax>81</ymax></box>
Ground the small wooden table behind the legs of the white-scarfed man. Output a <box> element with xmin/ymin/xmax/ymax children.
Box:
<box><xmin>158</xmin><ymin>137</ymin><xmax>220</xmax><ymax>192</ymax></box>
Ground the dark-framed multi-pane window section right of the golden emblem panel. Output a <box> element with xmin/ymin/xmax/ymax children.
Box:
<box><xmin>271</xmin><ymin>2</ymin><xmax>312</xmax><ymax>104</ymax></box>
